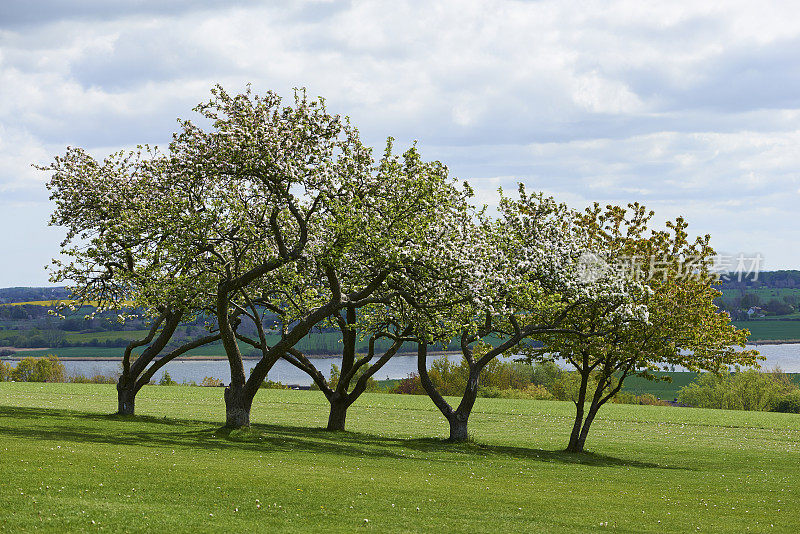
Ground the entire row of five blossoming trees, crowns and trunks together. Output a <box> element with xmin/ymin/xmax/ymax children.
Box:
<box><xmin>42</xmin><ymin>82</ymin><xmax>756</xmax><ymax>451</ymax></box>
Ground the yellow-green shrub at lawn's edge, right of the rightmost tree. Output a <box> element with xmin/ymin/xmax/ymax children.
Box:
<box><xmin>678</xmin><ymin>369</ymin><xmax>797</xmax><ymax>411</ymax></box>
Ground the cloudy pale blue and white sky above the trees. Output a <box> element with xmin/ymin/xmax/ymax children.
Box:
<box><xmin>0</xmin><ymin>0</ymin><xmax>800</xmax><ymax>287</ymax></box>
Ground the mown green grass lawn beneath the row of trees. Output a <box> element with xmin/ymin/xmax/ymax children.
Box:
<box><xmin>0</xmin><ymin>383</ymin><xmax>800</xmax><ymax>532</ymax></box>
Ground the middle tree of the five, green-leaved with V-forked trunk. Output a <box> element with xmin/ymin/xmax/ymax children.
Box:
<box><xmin>234</xmin><ymin>139</ymin><xmax>471</xmax><ymax>430</ymax></box>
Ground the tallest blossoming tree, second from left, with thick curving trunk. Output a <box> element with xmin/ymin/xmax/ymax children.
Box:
<box><xmin>159</xmin><ymin>87</ymin><xmax>386</xmax><ymax>427</ymax></box>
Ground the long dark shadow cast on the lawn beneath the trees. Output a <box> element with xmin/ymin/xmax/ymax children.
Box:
<box><xmin>0</xmin><ymin>406</ymin><xmax>686</xmax><ymax>469</ymax></box>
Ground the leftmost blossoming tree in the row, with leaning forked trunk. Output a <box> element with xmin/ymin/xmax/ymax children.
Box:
<box><xmin>45</xmin><ymin>147</ymin><xmax>220</xmax><ymax>415</ymax></box>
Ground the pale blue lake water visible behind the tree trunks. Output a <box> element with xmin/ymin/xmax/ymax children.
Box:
<box><xmin>18</xmin><ymin>343</ymin><xmax>800</xmax><ymax>386</ymax></box>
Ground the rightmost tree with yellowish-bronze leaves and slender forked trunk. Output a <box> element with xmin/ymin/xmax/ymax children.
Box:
<box><xmin>528</xmin><ymin>204</ymin><xmax>758</xmax><ymax>452</ymax></box>
